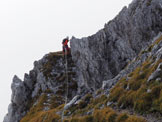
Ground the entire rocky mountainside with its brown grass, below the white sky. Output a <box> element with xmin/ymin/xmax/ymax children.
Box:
<box><xmin>3</xmin><ymin>0</ymin><xmax>162</xmax><ymax>122</ymax></box>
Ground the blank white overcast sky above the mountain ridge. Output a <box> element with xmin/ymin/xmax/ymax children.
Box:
<box><xmin>0</xmin><ymin>0</ymin><xmax>132</xmax><ymax>122</ymax></box>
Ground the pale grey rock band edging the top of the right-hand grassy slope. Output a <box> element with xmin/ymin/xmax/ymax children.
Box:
<box><xmin>102</xmin><ymin>33</ymin><xmax>162</xmax><ymax>94</ymax></box>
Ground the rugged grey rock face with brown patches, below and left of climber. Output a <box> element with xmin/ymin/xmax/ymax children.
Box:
<box><xmin>3</xmin><ymin>52</ymin><xmax>78</xmax><ymax>122</ymax></box>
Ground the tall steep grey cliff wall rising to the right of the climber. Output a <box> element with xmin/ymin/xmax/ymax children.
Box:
<box><xmin>71</xmin><ymin>0</ymin><xmax>162</xmax><ymax>90</ymax></box>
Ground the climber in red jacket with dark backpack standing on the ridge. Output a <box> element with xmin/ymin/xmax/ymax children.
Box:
<box><xmin>62</xmin><ymin>37</ymin><xmax>70</xmax><ymax>56</ymax></box>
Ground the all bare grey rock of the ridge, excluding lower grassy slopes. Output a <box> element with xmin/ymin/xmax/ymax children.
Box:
<box><xmin>3</xmin><ymin>0</ymin><xmax>162</xmax><ymax>122</ymax></box>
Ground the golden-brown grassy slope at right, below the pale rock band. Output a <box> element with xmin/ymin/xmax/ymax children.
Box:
<box><xmin>109</xmin><ymin>36</ymin><xmax>162</xmax><ymax>114</ymax></box>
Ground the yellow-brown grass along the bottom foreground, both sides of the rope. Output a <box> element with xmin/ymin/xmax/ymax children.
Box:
<box><xmin>20</xmin><ymin>93</ymin><xmax>146</xmax><ymax>122</ymax></box>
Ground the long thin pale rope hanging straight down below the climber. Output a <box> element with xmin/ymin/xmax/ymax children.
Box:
<box><xmin>61</xmin><ymin>48</ymin><xmax>69</xmax><ymax>122</ymax></box>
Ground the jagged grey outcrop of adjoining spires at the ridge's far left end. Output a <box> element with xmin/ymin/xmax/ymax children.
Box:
<box><xmin>4</xmin><ymin>70</ymin><xmax>36</xmax><ymax>122</ymax></box>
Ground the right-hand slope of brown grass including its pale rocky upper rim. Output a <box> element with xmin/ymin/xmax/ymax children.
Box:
<box><xmin>106</xmin><ymin>33</ymin><xmax>162</xmax><ymax>122</ymax></box>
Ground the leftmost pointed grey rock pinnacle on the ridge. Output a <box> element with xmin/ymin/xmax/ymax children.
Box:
<box><xmin>4</xmin><ymin>76</ymin><xmax>30</xmax><ymax>122</ymax></box>
